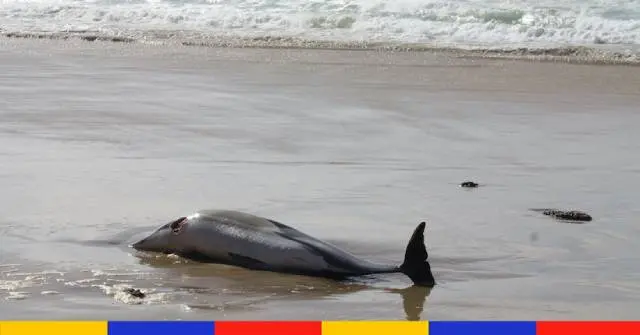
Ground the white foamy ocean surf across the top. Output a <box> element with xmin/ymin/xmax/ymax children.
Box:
<box><xmin>0</xmin><ymin>0</ymin><xmax>640</xmax><ymax>49</ymax></box>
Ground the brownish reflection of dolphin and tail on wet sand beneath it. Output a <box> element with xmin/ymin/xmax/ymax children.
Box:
<box><xmin>135</xmin><ymin>252</ymin><xmax>431</xmax><ymax>321</ymax></box>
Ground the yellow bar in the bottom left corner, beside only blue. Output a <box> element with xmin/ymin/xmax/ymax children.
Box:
<box><xmin>0</xmin><ymin>321</ymin><xmax>108</xmax><ymax>335</ymax></box>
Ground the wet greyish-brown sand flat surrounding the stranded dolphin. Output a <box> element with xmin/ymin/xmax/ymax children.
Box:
<box><xmin>0</xmin><ymin>40</ymin><xmax>640</xmax><ymax>320</ymax></box>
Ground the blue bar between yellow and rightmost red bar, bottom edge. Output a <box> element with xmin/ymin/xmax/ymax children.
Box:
<box><xmin>429</xmin><ymin>321</ymin><xmax>536</xmax><ymax>335</ymax></box>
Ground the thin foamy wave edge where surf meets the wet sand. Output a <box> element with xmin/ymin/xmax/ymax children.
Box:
<box><xmin>5</xmin><ymin>30</ymin><xmax>640</xmax><ymax>66</ymax></box>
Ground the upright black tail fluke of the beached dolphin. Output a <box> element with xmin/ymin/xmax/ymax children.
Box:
<box><xmin>400</xmin><ymin>222</ymin><xmax>436</xmax><ymax>287</ymax></box>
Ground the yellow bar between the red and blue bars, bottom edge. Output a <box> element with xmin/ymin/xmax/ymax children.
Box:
<box><xmin>320</xmin><ymin>321</ymin><xmax>429</xmax><ymax>335</ymax></box>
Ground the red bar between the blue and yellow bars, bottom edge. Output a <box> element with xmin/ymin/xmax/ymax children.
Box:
<box><xmin>214</xmin><ymin>321</ymin><xmax>322</xmax><ymax>335</ymax></box>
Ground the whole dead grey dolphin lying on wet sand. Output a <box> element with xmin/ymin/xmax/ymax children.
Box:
<box><xmin>132</xmin><ymin>210</ymin><xmax>436</xmax><ymax>287</ymax></box>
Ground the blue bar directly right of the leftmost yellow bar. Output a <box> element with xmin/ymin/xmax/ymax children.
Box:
<box><xmin>108</xmin><ymin>321</ymin><xmax>215</xmax><ymax>335</ymax></box>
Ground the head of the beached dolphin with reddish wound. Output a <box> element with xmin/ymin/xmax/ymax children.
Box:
<box><xmin>131</xmin><ymin>217</ymin><xmax>189</xmax><ymax>254</ymax></box>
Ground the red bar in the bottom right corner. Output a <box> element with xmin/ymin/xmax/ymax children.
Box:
<box><xmin>536</xmin><ymin>321</ymin><xmax>640</xmax><ymax>335</ymax></box>
